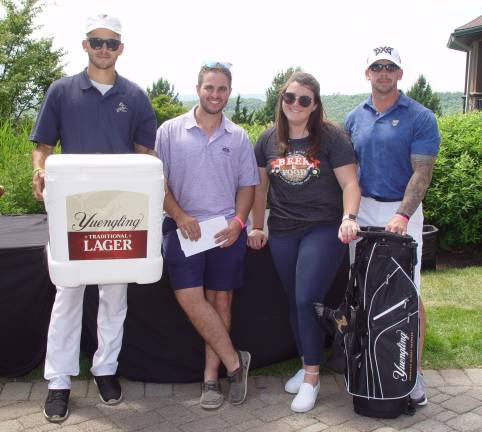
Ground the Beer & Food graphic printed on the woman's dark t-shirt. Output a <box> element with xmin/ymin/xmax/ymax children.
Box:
<box><xmin>271</xmin><ymin>153</ymin><xmax>320</xmax><ymax>184</ymax></box>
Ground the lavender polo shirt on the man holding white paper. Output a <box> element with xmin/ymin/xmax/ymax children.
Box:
<box><xmin>155</xmin><ymin>107</ymin><xmax>259</xmax><ymax>221</ymax></box>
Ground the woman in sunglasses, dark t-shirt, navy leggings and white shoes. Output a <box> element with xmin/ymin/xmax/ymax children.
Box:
<box><xmin>248</xmin><ymin>72</ymin><xmax>360</xmax><ymax>412</ymax></box>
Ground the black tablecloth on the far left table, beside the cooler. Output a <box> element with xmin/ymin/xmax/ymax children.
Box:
<box><xmin>0</xmin><ymin>215</ymin><xmax>55</xmax><ymax>377</ymax></box>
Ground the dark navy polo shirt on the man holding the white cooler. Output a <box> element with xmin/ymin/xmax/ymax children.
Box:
<box><xmin>30</xmin><ymin>70</ymin><xmax>156</xmax><ymax>153</ymax></box>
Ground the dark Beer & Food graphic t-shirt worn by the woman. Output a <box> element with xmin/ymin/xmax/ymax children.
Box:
<box><xmin>255</xmin><ymin>125</ymin><xmax>355</xmax><ymax>234</ymax></box>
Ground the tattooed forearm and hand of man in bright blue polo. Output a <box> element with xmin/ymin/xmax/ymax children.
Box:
<box><xmin>385</xmin><ymin>154</ymin><xmax>435</xmax><ymax>234</ymax></box>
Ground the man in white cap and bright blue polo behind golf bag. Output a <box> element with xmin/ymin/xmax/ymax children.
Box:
<box><xmin>345</xmin><ymin>46</ymin><xmax>440</xmax><ymax>405</ymax></box>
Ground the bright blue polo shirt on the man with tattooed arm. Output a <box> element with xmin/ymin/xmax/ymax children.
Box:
<box><xmin>345</xmin><ymin>92</ymin><xmax>440</xmax><ymax>201</ymax></box>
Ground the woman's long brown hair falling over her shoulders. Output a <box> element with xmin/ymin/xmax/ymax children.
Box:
<box><xmin>275</xmin><ymin>72</ymin><xmax>326</xmax><ymax>159</ymax></box>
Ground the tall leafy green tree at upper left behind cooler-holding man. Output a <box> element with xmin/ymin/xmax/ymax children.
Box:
<box><xmin>0</xmin><ymin>0</ymin><xmax>64</xmax><ymax>122</ymax></box>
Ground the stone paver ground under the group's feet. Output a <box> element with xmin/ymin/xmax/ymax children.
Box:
<box><xmin>0</xmin><ymin>368</ymin><xmax>482</xmax><ymax>432</ymax></box>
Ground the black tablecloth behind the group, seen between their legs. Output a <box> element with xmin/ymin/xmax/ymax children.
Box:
<box><xmin>82</xmin><ymin>247</ymin><xmax>348</xmax><ymax>382</ymax></box>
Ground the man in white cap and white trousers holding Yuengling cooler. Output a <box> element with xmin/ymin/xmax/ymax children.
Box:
<box><xmin>30</xmin><ymin>15</ymin><xmax>156</xmax><ymax>422</ymax></box>
